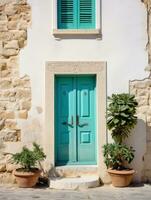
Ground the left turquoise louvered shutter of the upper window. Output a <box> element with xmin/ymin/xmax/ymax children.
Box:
<box><xmin>58</xmin><ymin>0</ymin><xmax>77</xmax><ymax>29</ymax></box>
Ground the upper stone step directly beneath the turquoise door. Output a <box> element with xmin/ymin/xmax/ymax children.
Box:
<box><xmin>53</xmin><ymin>165</ymin><xmax>98</xmax><ymax>177</ymax></box>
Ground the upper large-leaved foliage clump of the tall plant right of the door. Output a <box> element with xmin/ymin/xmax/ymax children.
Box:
<box><xmin>107</xmin><ymin>93</ymin><xmax>137</xmax><ymax>144</ymax></box>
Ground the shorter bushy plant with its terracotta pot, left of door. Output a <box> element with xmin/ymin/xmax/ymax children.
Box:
<box><xmin>12</xmin><ymin>143</ymin><xmax>46</xmax><ymax>188</ymax></box>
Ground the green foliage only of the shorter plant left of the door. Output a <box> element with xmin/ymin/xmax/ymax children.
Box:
<box><xmin>12</xmin><ymin>143</ymin><xmax>46</xmax><ymax>172</ymax></box>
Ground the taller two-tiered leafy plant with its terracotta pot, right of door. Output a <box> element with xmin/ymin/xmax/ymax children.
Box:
<box><xmin>103</xmin><ymin>93</ymin><xmax>137</xmax><ymax>187</ymax></box>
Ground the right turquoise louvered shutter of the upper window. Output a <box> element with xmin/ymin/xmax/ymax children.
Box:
<box><xmin>78</xmin><ymin>0</ymin><xmax>95</xmax><ymax>29</ymax></box>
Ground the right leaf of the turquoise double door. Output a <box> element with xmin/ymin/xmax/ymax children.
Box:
<box><xmin>77</xmin><ymin>76</ymin><xmax>96</xmax><ymax>164</ymax></box>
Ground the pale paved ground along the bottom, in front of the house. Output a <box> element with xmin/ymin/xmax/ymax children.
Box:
<box><xmin>0</xmin><ymin>185</ymin><xmax>151</xmax><ymax>200</ymax></box>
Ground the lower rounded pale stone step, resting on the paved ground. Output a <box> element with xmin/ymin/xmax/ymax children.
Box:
<box><xmin>50</xmin><ymin>176</ymin><xmax>100</xmax><ymax>190</ymax></box>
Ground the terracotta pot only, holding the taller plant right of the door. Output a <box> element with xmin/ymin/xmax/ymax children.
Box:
<box><xmin>108</xmin><ymin>169</ymin><xmax>135</xmax><ymax>187</ymax></box>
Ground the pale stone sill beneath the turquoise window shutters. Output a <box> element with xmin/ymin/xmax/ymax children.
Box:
<box><xmin>53</xmin><ymin>29</ymin><xmax>101</xmax><ymax>36</ymax></box>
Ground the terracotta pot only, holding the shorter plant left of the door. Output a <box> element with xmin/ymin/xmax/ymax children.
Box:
<box><xmin>14</xmin><ymin>169</ymin><xmax>41</xmax><ymax>188</ymax></box>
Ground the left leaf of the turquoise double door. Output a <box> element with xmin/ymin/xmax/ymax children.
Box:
<box><xmin>55</xmin><ymin>77</ymin><xmax>76</xmax><ymax>164</ymax></box>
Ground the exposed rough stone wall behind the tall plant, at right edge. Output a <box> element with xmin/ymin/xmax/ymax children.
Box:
<box><xmin>130</xmin><ymin>78</ymin><xmax>151</xmax><ymax>182</ymax></box>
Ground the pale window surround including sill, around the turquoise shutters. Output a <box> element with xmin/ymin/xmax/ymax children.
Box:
<box><xmin>52</xmin><ymin>0</ymin><xmax>101</xmax><ymax>35</ymax></box>
